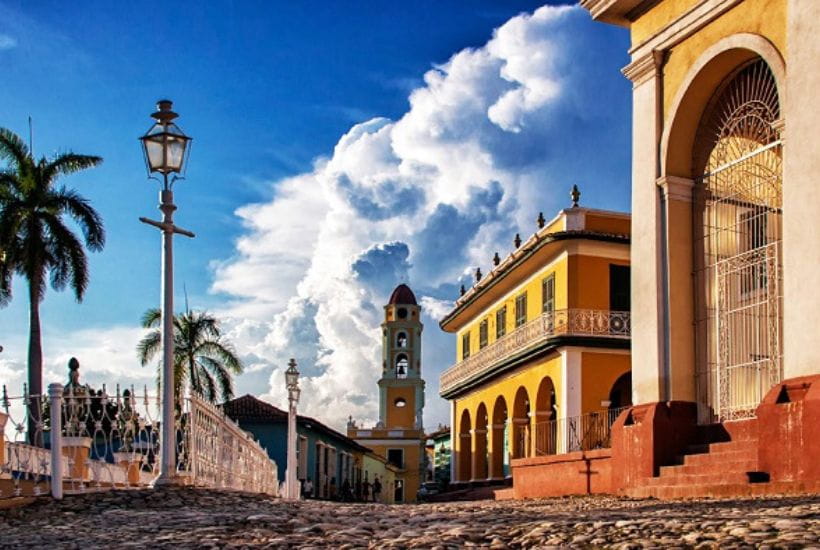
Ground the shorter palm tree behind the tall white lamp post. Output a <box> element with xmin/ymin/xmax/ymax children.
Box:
<box><xmin>137</xmin><ymin>309</ymin><xmax>243</xmax><ymax>403</ymax></box>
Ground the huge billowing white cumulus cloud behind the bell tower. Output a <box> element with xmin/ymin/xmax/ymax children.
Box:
<box><xmin>212</xmin><ymin>7</ymin><xmax>628</xmax><ymax>436</ymax></box>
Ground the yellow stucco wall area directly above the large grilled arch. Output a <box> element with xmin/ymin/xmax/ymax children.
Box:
<box><xmin>664</xmin><ymin>0</ymin><xmax>786</xmax><ymax>117</ymax></box>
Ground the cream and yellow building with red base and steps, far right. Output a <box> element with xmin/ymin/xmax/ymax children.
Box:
<box><xmin>581</xmin><ymin>0</ymin><xmax>820</xmax><ymax>496</ymax></box>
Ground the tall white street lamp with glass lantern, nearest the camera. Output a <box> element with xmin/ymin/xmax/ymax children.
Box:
<box><xmin>139</xmin><ymin>99</ymin><xmax>194</xmax><ymax>485</ymax></box>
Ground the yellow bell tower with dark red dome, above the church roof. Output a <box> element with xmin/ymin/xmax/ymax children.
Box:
<box><xmin>379</xmin><ymin>284</ymin><xmax>424</xmax><ymax>430</ymax></box>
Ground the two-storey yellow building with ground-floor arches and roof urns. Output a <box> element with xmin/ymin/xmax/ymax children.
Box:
<box><xmin>440</xmin><ymin>198</ymin><xmax>631</xmax><ymax>483</ymax></box>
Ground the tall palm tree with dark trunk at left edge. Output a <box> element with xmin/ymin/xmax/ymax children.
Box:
<box><xmin>0</xmin><ymin>128</ymin><xmax>105</xmax><ymax>444</ymax></box>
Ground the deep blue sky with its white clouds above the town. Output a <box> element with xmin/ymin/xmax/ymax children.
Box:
<box><xmin>0</xmin><ymin>0</ymin><xmax>630</xmax><ymax>432</ymax></box>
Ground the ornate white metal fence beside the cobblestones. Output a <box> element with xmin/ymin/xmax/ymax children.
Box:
<box><xmin>0</xmin><ymin>385</ymin><xmax>279</xmax><ymax>499</ymax></box>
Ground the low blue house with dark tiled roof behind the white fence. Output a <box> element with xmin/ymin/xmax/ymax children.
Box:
<box><xmin>223</xmin><ymin>395</ymin><xmax>370</xmax><ymax>499</ymax></box>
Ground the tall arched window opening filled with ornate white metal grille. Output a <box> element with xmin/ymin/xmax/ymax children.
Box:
<box><xmin>693</xmin><ymin>58</ymin><xmax>783</xmax><ymax>421</ymax></box>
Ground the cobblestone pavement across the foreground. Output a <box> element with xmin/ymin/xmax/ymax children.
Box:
<box><xmin>0</xmin><ymin>488</ymin><xmax>820</xmax><ymax>549</ymax></box>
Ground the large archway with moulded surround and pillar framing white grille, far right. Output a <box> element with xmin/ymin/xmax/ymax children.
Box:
<box><xmin>660</xmin><ymin>33</ymin><xmax>785</xmax><ymax>423</ymax></box>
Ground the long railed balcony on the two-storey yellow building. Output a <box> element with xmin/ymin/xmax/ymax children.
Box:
<box><xmin>439</xmin><ymin>309</ymin><xmax>631</xmax><ymax>393</ymax></box>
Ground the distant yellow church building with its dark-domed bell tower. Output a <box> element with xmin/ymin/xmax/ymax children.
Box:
<box><xmin>347</xmin><ymin>284</ymin><xmax>426</xmax><ymax>503</ymax></box>
